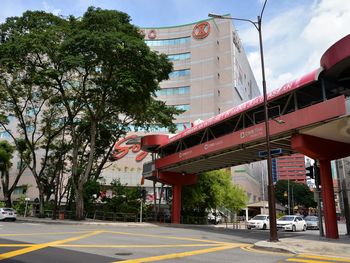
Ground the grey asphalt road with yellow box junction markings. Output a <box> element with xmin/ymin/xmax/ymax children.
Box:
<box><xmin>0</xmin><ymin>222</ymin><xmax>344</xmax><ymax>263</ymax></box>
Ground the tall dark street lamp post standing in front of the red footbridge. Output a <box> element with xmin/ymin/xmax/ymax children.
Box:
<box><xmin>208</xmin><ymin>0</ymin><xmax>278</xmax><ymax>242</ymax></box>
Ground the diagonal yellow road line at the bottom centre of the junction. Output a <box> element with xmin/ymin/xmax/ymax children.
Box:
<box><xmin>115</xmin><ymin>245</ymin><xmax>238</xmax><ymax>263</ymax></box>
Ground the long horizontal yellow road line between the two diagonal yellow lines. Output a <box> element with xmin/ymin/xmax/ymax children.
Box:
<box><xmin>55</xmin><ymin>244</ymin><xmax>220</xmax><ymax>248</ymax></box>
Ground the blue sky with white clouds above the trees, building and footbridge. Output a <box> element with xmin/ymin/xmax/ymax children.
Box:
<box><xmin>0</xmin><ymin>0</ymin><xmax>350</xmax><ymax>91</ymax></box>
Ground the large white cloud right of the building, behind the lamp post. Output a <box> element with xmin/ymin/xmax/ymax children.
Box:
<box><xmin>239</xmin><ymin>0</ymin><xmax>350</xmax><ymax>93</ymax></box>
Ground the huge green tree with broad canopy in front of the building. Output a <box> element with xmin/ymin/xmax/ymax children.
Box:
<box><xmin>0</xmin><ymin>7</ymin><xmax>181</xmax><ymax>219</ymax></box>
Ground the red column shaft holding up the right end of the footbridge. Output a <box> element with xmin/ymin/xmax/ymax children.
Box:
<box><xmin>320</xmin><ymin>160</ymin><xmax>339</xmax><ymax>239</ymax></box>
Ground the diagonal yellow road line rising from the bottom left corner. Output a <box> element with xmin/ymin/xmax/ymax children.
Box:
<box><xmin>0</xmin><ymin>231</ymin><xmax>103</xmax><ymax>260</ymax></box>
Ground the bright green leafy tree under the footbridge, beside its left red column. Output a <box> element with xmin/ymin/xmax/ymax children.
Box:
<box><xmin>182</xmin><ymin>170</ymin><xmax>247</xmax><ymax>219</ymax></box>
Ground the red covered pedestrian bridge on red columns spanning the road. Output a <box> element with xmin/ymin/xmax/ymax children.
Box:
<box><xmin>141</xmin><ymin>35</ymin><xmax>350</xmax><ymax>238</ymax></box>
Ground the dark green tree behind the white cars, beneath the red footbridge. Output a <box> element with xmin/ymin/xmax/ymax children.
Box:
<box><xmin>275</xmin><ymin>180</ymin><xmax>317</xmax><ymax>207</ymax></box>
